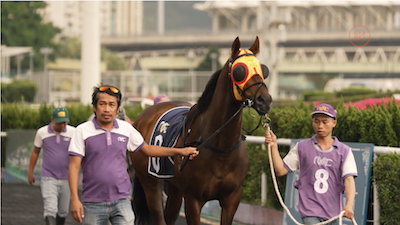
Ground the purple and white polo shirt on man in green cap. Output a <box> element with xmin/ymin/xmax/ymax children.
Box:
<box><xmin>33</xmin><ymin>123</ymin><xmax>75</xmax><ymax>180</ymax></box>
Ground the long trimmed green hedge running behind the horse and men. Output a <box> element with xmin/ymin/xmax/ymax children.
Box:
<box><xmin>1</xmin><ymin>101</ymin><xmax>400</xmax><ymax>221</ymax></box>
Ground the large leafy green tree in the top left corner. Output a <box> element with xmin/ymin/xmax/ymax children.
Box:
<box><xmin>1</xmin><ymin>2</ymin><xmax>61</xmax><ymax>70</ymax></box>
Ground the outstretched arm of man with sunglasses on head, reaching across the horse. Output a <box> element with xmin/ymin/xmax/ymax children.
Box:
<box><xmin>140</xmin><ymin>142</ymin><xmax>199</xmax><ymax>159</ymax></box>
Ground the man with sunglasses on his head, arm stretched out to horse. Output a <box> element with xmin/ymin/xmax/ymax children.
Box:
<box><xmin>69</xmin><ymin>85</ymin><xmax>198</xmax><ymax>225</ymax></box>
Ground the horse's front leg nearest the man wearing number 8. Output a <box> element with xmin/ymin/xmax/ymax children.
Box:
<box><xmin>220</xmin><ymin>188</ymin><xmax>242</xmax><ymax>225</ymax></box>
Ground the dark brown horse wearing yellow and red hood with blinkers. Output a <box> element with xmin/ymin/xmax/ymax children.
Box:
<box><xmin>131</xmin><ymin>37</ymin><xmax>272</xmax><ymax>225</ymax></box>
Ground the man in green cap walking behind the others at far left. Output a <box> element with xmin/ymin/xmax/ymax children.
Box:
<box><xmin>28</xmin><ymin>107</ymin><xmax>75</xmax><ymax>225</ymax></box>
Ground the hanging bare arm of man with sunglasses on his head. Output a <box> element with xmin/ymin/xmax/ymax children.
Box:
<box><xmin>68</xmin><ymin>156</ymin><xmax>84</xmax><ymax>223</ymax></box>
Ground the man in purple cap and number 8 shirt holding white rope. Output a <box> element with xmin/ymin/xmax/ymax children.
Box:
<box><xmin>265</xmin><ymin>104</ymin><xmax>357</xmax><ymax>225</ymax></box>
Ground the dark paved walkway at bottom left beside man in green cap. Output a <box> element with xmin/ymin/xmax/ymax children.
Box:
<box><xmin>1</xmin><ymin>182</ymin><xmax>212</xmax><ymax>225</ymax></box>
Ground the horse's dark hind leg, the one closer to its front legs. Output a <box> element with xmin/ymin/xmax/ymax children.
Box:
<box><xmin>164</xmin><ymin>183</ymin><xmax>183</xmax><ymax>225</ymax></box>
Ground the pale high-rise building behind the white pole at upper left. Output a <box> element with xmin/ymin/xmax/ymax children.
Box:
<box><xmin>41</xmin><ymin>1</ymin><xmax>143</xmax><ymax>37</ymax></box>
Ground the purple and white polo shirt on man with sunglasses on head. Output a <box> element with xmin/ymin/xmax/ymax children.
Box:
<box><xmin>68</xmin><ymin>118</ymin><xmax>144</xmax><ymax>202</ymax></box>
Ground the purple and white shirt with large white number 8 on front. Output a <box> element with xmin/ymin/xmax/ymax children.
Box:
<box><xmin>283</xmin><ymin>136</ymin><xmax>357</xmax><ymax>219</ymax></box>
